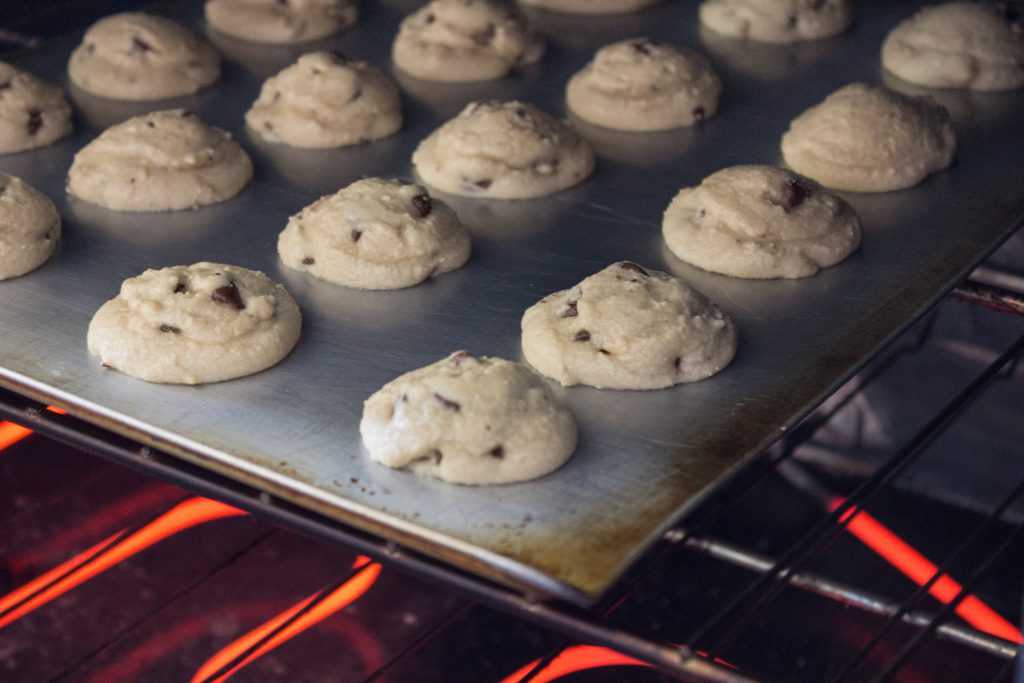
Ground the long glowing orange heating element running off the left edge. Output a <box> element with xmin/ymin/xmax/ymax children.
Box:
<box><xmin>0</xmin><ymin>498</ymin><xmax>246</xmax><ymax>629</ymax></box>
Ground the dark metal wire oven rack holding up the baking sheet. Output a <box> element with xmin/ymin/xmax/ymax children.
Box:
<box><xmin>0</xmin><ymin>276</ymin><xmax>1024</xmax><ymax>682</ymax></box>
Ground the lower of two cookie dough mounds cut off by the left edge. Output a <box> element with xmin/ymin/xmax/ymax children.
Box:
<box><xmin>0</xmin><ymin>173</ymin><xmax>60</xmax><ymax>280</ymax></box>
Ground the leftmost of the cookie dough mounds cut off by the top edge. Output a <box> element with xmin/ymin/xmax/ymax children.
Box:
<box><xmin>205</xmin><ymin>0</ymin><xmax>358</xmax><ymax>44</ymax></box>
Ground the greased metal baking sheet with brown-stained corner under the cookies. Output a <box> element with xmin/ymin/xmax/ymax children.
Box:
<box><xmin>0</xmin><ymin>0</ymin><xmax>1024</xmax><ymax>603</ymax></box>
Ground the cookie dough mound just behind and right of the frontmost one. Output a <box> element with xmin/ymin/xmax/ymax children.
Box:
<box><xmin>522</xmin><ymin>261</ymin><xmax>736</xmax><ymax>389</ymax></box>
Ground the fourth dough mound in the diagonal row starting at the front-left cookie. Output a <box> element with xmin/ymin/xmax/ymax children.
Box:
<box><xmin>565</xmin><ymin>39</ymin><xmax>722</xmax><ymax>131</ymax></box>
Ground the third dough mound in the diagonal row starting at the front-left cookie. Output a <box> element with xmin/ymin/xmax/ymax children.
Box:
<box><xmin>413</xmin><ymin>101</ymin><xmax>594</xmax><ymax>200</ymax></box>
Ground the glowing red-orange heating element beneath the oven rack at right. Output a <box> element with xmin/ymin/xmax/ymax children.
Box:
<box><xmin>828</xmin><ymin>497</ymin><xmax>1024</xmax><ymax>643</ymax></box>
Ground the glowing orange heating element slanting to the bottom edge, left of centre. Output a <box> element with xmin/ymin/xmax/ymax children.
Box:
<box><xmin>191</xmin><ymin>556</ymin><xmax>381</xmax><ymax>683</ymax></box>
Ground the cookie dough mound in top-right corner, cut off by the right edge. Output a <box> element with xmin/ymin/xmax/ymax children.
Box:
<box><xmin>882</xmin><ymin>2</ymin><xmax>1024</xmax><ymax>90</ymax></box>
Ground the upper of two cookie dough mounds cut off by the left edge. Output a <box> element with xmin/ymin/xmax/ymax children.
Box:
<box><xmin>0</xmin><ymin>61</ymin><xmax>71</xmax><ymax>154</ymax></box>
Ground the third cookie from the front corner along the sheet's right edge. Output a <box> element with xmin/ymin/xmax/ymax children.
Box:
<box><xmin>662</xmin><ymin>166</ymin><xmax>861</xmax><ymax>279</ymax></box>
